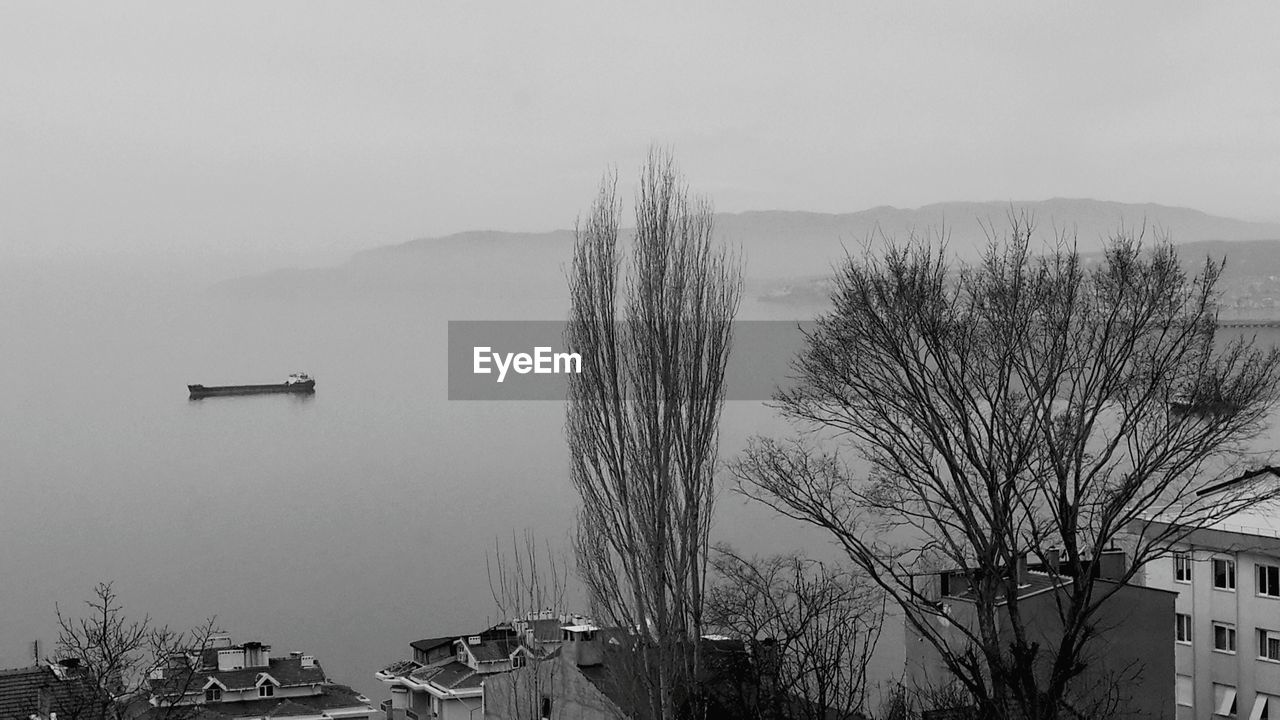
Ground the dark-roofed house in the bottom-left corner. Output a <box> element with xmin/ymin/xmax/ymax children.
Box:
<box><xmin>0</xmin><ymin>660</ymin><xmax>104</xmax><ymax>720</ymax></box>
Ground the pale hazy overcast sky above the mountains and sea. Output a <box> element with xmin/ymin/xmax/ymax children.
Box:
<box><xmin>0</xmin><ymin>0</ymin><xmax>1280</xmax><ymax>261</ymax></box>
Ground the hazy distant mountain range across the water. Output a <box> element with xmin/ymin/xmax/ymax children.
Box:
<box><xmin>215</xmin><ymin>199</ymin><xmax>1280</xmax><ymax>311</ymax></box>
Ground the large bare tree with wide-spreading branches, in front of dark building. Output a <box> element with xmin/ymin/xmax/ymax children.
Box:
<box><xmin>736</xmin><ymin>217</ymin><xmax>1280</xmax><ymax>719</ymax></box>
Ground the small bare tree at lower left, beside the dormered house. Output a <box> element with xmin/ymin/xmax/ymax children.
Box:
<box><xmin>55</xmin><ymin>583</ymin><xmax>215</xmax><ymax>720</ymax></box>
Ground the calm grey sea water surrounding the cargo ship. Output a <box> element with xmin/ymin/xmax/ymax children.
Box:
<box><xmin>0</xmin><ymin>267</ymin><xmax>820</xmax><ymax>698</ymax></box>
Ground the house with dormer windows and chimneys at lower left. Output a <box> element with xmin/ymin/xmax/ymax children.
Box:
<box><xmin>148</xmin><ymin>635</ymin><xmax>376</xmax><ymax>720</ymax></box>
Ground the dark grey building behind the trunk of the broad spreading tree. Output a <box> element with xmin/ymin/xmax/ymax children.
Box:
<box><xmin>905</xmin><ymin>550</ymin><xmax>1175</xmax><ymax>717</ymax></box>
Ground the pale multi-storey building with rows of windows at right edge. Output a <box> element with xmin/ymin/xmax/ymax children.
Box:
<box><xmin>1132</xmin><ymin>491</ymin><xmax>1280</xmax><ymax>720</ymax></box>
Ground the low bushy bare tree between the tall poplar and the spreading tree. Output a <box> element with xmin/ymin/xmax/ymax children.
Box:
<box><xmin>707</xmin><ymin>546</ymin><xmax>884</xmax><ymax>720</ymax></box>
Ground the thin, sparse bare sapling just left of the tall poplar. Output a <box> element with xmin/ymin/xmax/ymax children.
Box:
<box><xmin>485</xmin><ymin>530</ymin><xmax>570</xmax><ymax>720</ymax></box>
